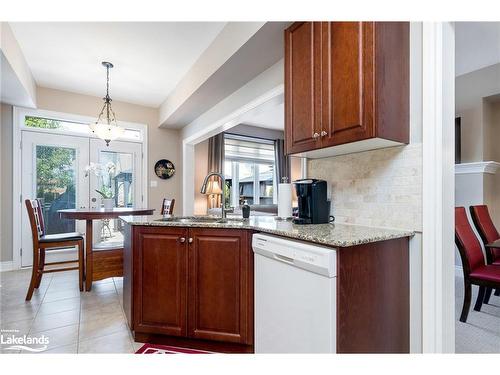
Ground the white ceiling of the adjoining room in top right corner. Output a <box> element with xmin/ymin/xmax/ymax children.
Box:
<box><xmin>455</xmin><ymin>22</ymin><xmax>500</xmax><ymax>76</ymax></box>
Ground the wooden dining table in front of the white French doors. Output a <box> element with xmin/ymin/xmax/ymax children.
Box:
<box><xmin>57</xmin><ymin>207</ymin><xmax>154</xmax><ymax>292</ymax></box>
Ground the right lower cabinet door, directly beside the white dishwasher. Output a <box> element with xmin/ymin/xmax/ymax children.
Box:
<box><xmin>188</xmin><ymin>228</ymin><xmax>253</xmax><ymax>344</ymax></box>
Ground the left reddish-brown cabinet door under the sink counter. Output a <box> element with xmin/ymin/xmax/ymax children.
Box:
<box><xmin>134</xmin><ymin>228</ymin><xmax>187</xmax><ymax>336</ymax></box>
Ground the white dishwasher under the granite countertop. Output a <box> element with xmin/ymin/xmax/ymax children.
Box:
<box><xmin>252</xmin><ymin>234</ymin><xmax>337</xmax><ymax>353</ymax></box>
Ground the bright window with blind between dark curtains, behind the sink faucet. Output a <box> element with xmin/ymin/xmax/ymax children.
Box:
<box><xmin>224</xmin><ymin>134</ymin><xmax>276</xmax><ymax>207</ymax></box>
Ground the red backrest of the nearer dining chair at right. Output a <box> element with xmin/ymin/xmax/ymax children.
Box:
<box><xmin>455</xmin><ymin>207</ymin><xmax>485</xmax><ymax>275</ymax></box>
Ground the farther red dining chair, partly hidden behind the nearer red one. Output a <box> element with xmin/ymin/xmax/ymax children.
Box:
<box><xmin>469</xmin><ymin>204</ymin><xmax>500</xmax><ymax>303</ymax></box>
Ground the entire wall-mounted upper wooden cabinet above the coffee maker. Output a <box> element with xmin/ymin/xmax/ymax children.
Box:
<box><xmin>285</xmin><ymin>22</ymin><xmax>410</xmax><ymax>158</ymax></box>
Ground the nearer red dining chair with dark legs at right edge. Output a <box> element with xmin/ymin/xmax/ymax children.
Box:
<box><xmin>455</xmin><ymin>207</ymin><xmax>500</xmax><ymax>323</ymax></box>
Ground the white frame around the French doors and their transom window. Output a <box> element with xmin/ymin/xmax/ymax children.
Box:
<box><xmin>12</xmin><ymin>107</ymin><xmax>148</xmax><ymax>269</ymax></box>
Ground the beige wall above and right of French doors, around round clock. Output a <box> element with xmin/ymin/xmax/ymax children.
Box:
<box><xmin>37</xmin><ymin>87</ymin><xmax>182</xmax><ymax>213</ymax></box>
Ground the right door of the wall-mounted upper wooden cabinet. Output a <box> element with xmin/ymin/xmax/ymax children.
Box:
<box><xmin>321</xmin><ymin>22</ymin><xmax>375</xmax><ymax>147</ymax></box>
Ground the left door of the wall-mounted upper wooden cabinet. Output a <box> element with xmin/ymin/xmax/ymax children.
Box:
<box><xmin>285</xmin><ymin>22</ymin><xmax>321</xmax><ymax>154</ymax></box>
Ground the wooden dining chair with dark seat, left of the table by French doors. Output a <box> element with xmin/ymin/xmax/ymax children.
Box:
<box><xmin>25</xmin><ymin>199</ymin><xmax>84</xmax><ymax>301</ymax></box>
